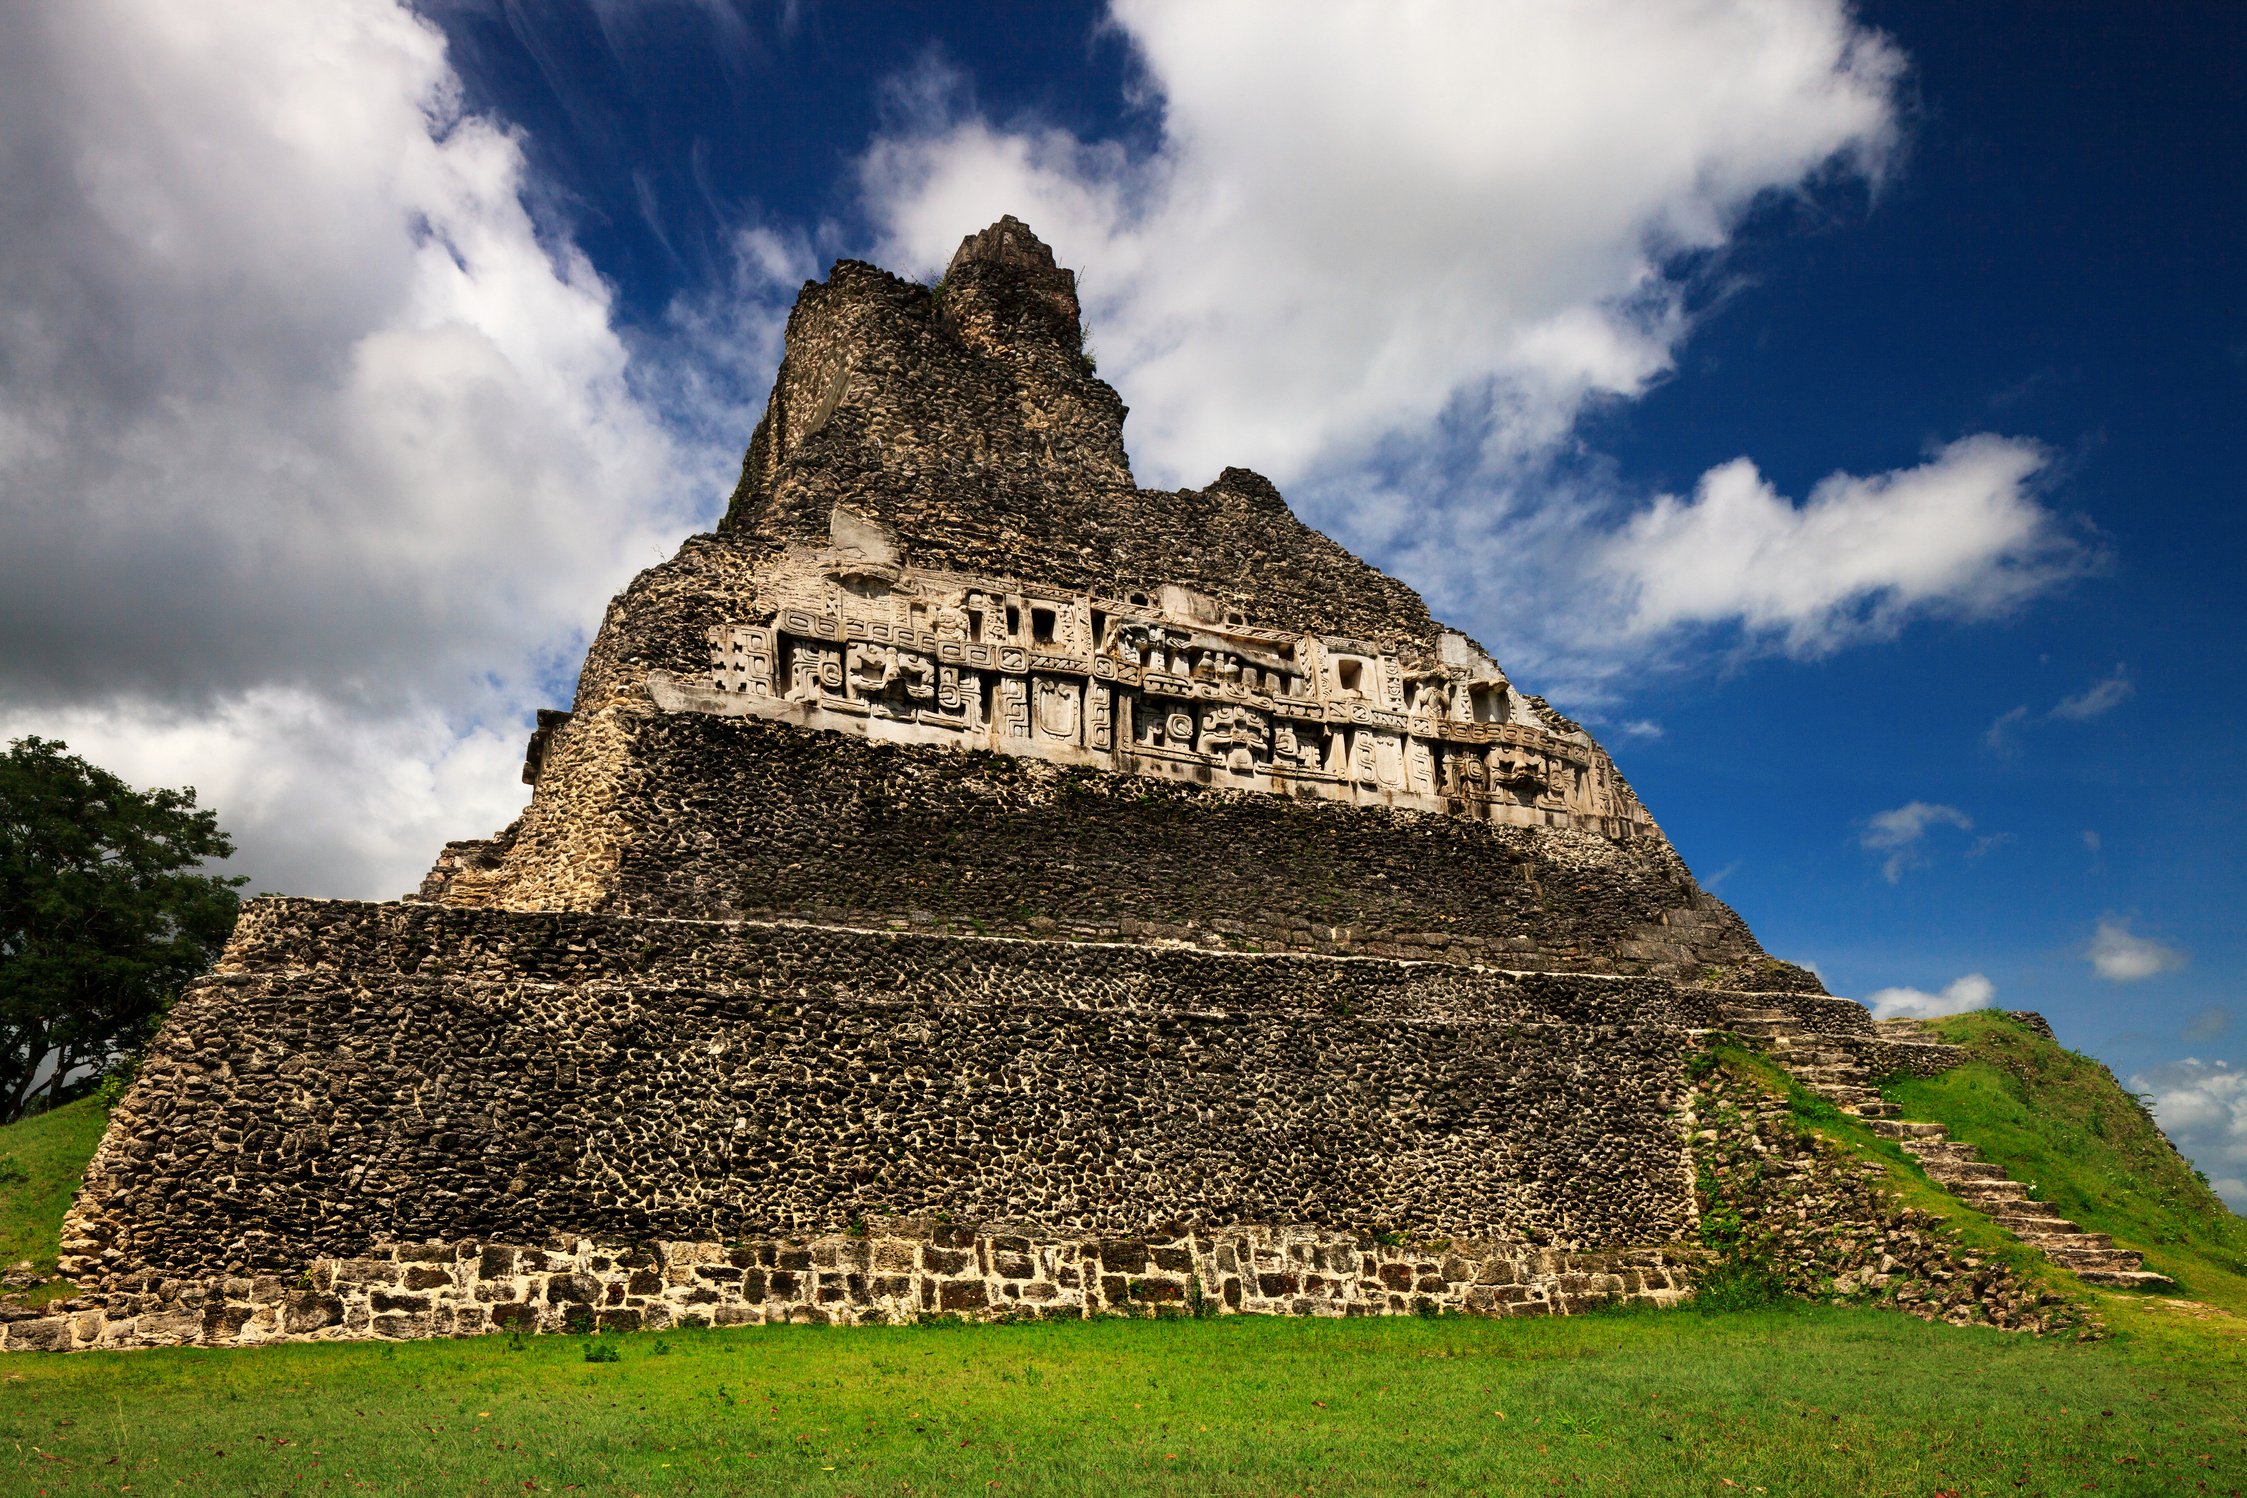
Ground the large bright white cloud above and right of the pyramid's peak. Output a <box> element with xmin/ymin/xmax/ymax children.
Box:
<box><xmin>863</xmin><ymin>0</ymin><xmax>1903</xmax><ymax>483</ymax></box>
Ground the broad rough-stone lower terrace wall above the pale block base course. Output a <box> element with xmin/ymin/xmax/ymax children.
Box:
<box><xmin>65</xmin><ymin>898</ymin><xmax>1696</xmax><ymax>1285</ymax></box>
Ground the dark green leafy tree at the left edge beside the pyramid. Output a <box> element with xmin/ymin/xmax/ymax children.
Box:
<box><xmin>0</xmin><ymin>739</ymin><xmax>243</xmax><ymax>1123</ymax></box>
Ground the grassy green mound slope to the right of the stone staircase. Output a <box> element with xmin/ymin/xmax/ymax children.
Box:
<box><xmin>1885</xmin><ymin>1011</ymin><xmax>2247</xmax><ymax>1316</ymax></box>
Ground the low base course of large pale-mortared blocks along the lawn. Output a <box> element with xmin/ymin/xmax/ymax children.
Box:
<box><xmin>0</xmin><ymin>1220</ymin><xmax>1694</xmax><ymax>1352</ymax></box>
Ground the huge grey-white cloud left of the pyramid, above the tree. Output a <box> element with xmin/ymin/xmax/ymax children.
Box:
<box><xmin>0</xmin><ymin>0</ymin><xmax>721</xmax><ymax>894</ymax></box>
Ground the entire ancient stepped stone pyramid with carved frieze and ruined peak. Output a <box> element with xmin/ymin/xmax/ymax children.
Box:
<box><xmin>26</xmin><ymin>218</ymin><xmax>2058</xmax><ymax>1345</ymax></box>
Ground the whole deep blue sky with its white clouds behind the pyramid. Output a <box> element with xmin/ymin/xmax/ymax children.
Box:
<box><xmin>0</xmin><ymin>0</ymin><xmax>2247</xmax><ymax>1204</ymax></box>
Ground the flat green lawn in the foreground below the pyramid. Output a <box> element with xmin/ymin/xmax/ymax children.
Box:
<box><xmin>0</xmin><ymin>1307</ymin><xmax>2247</xmax><ymax>1498</ymax></box>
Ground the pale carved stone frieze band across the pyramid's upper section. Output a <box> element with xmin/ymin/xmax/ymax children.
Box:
<box><xmin>647</xmin><ymin>510</ymin><xmax>1658</xmax><ymax>840</ymax></box>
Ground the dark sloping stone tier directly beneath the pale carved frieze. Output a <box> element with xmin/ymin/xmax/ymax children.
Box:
<box><xmin>438</xmin><ymin>712</ymin><xmax>1815</xmax><ymax>988</ymax></box>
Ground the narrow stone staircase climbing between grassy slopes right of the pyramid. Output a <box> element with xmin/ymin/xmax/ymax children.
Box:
<box><xmin>1723</xmin><ymin>1004</ymin><xmax>2175</xmax><ymax>1289</ymax></box>
